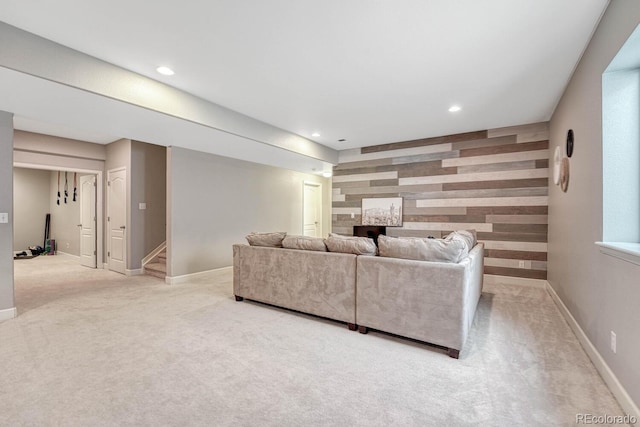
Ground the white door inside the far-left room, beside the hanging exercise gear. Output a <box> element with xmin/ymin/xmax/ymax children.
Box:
<box><xmin>78</xmin><ymin>175</ymin><xmax>97</xmax><ymax>268</ymax></box>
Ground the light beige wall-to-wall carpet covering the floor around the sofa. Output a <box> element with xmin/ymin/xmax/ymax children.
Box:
<box><xmin>0</xmin><ymin>256</ymin><xmax>623</xmax><ymax>426</ymax></box>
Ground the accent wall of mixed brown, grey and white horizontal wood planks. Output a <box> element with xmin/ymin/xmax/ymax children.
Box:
<box><xmin>332</xmin><ymin>122</ymin><xmax>549</xmax><ymax>279</ymax></box>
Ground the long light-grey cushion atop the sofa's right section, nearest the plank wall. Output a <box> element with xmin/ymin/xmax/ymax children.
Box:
<box><xmin>378</xmin><ymin>235</ymin><xmax>469</xmax><ymax>262</ymax></box>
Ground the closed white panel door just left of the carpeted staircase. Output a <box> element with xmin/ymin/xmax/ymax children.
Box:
<box><xmin>107</xmin><ymin>169</ymin><xmax>127</xmax><ymax>274</ymax></box>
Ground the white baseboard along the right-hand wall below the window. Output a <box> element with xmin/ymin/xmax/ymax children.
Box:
<box><xmin>545</xmin><ymin>282</ymin><xmax>640</xmax><ymax>418</ymax></box>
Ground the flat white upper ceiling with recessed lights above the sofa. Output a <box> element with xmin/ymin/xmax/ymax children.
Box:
<box><xmin>0</xmin><ymin>0</ymin><xmax>608</xmax><ymax>155</ymax></box>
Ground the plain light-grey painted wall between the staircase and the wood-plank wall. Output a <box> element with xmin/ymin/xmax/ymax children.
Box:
<box><xmin>167</xmin><ymin>147</ymin><xmax>331</xmax><ymax>277</ymax></box>
